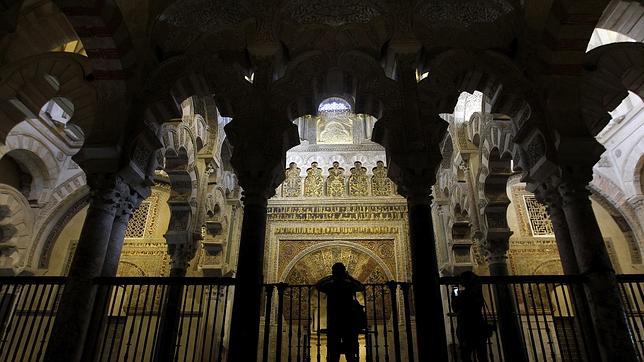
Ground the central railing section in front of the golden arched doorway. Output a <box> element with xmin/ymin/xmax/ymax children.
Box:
<box><xmin>257</xmin><ymin>282</ymin><xmax>417</xmax><ymax>361</ymax></box>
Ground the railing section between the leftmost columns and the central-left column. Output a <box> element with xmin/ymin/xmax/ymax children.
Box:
<box><xmin>90</xmin><ymin>277</ymin><xmax>234</xmax><ymax>361</ymax></box>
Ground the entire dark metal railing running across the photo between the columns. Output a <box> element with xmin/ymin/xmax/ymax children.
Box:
<box><xmin>0</xmin><ymin>275</ymin><xmax>644</xmax><ymax>361</ymax></box>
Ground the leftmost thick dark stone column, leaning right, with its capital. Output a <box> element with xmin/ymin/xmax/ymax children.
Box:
<box><xmin>44</xmin><ymin>175</ymin><xmax>129</xmax><ymax>361</ymax></box>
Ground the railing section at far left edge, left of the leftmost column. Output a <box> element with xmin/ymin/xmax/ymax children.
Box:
<box><xmin>0</xmin><ymin>277</ymin><xmax>66</xmax><ymax>361</ymax></box>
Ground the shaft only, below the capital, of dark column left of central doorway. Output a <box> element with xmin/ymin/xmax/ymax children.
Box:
<box><xmin>228</xmin><ymin>191</ymin><xmax>267</xmax><ymax>361</ymax></box>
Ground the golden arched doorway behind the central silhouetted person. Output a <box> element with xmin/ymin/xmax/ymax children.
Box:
<box><xmin>282</xmin><ymin>241</ymin><xmax>393</xmax><ymax>361</ymax></box>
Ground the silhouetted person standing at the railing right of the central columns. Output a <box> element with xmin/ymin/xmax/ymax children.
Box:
<box><xmin>452</xmin><ymin>271</ymin><xmax>490</xmax><ymax>362</ymax></box>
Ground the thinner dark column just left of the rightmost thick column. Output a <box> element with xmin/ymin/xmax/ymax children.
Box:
<box><xmin>535</xmin><ymin>185</ymin><xmax>601</xmax><ymax>361</ymax></box>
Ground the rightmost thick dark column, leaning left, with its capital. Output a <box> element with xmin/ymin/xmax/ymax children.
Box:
<box><xmin>558</xmin><ymin>174</ymin><xmax>636</xmax><ymax>361</ymax></box>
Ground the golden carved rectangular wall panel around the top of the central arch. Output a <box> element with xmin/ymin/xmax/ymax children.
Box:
<box><xmin>266</xmin><ymin>198</ymin><xmax>409</xmax><ymax>284</ymax></box>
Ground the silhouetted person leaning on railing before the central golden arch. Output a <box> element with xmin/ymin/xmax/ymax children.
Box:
<box><xmin>317</xmin><ymin>263</ymin><xmax>366</xmax><ymax>362</ymax></box>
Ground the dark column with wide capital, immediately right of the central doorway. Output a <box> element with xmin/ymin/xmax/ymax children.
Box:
<box><xmin>373</xmin><ymin>109</ymin><xmax>448</xmax><ymax>361</ymax></box>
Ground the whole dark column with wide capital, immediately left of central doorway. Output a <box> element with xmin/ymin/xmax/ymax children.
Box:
<box><xmin>225</xmin><ymin>110</ymin><xmax>299</xmax><ymax>361</ymax></box>
